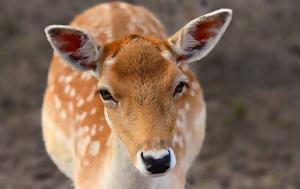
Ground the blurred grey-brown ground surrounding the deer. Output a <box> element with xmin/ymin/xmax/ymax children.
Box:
<box><xmin>0</xmin><ymin>0</ymin><xmax>300</xmax><ymax>189</ymax></box>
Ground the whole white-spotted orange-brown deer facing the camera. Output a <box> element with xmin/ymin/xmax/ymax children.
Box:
<box><xmin>42</xmin><ymin>2</ymin><xmax>232</xmax><ymax>189</ymax></box>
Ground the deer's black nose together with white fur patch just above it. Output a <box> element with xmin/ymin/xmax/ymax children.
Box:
<box><xmin>141</xmin><ymin>149</ymin><xmax>171</xmax><ymax>174</ymax></box>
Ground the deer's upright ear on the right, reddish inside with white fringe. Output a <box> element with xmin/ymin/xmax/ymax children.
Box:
<box><xmin>168</xmin><ymin>9</ymin><xmax>232</xmax><ymax>63</ymax></box>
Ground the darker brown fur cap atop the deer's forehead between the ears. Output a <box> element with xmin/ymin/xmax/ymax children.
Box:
<box><xmin>108</xmin><ymin>35</ymin><xmax>170</xmax><ymax>79</ymax></box>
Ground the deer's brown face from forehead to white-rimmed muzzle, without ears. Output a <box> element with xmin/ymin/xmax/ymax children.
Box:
<box><xmin>98</xmin><ymin>36</ymin><xmax>187</xmax><ymax>175</ymax></box>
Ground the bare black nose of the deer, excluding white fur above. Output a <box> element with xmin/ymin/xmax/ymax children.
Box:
<box><xmin>141</xmin><ymin>150</ymin><xmax>171</xmax><ymax>174</ymax></box>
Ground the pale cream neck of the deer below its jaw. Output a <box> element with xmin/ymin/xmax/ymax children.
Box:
<box><xmin>101</xmin><ymin>131</ymin><xmax>170</xmax><ymax>189</ymax></box>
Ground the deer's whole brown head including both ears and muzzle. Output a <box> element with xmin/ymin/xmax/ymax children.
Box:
<box><xmin>46</xmin><ymin>9</ymin><xmax>231</xmax><ymax>176</ymax></box>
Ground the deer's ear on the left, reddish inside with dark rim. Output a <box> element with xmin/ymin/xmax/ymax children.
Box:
<box><xmin>45</xmin><ymin>25</ymin><xmax>102</xmax><ymax>71</ymax></box>
